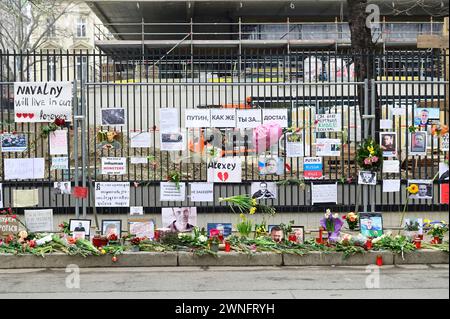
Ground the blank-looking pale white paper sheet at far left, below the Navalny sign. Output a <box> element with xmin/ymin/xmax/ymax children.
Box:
<box><xmin>4</xmin><ymin>158</ymin><xmax>45</xmax><ymax>180</ymax></box>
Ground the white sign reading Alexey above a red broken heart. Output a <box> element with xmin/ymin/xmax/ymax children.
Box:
<box><xmin>208</xmin><ymin>158</ymin><xmax>242</xmax><ymax>183</ymax></box>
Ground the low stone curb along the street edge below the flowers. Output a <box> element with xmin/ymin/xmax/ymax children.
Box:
<box><xmin>0</xmin><ymin>249</ymin><xmax>449</xmax><ymax>269</ymax></box>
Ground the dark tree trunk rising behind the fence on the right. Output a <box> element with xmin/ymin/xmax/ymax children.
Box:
<box><xmin>347</xmin><ymin>0</ymin><xmax>381</xmax><ymax>140</ymax></box>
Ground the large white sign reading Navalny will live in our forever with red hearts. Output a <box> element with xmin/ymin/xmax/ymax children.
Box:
<box><xmin>14</xmin><ymin>82</ymin><xmax>72</xmax><ymax>123</ymax></box>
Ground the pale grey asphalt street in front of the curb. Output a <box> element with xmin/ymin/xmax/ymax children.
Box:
<box><xmin>0</xmin><ymin>265</ymin><xmax>449</xmax><ymax>299</ymax></box>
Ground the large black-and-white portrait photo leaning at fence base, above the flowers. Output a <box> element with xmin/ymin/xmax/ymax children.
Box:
<box><xmin>162</xmin><ymin>207</ymin><xmax>197</xmax><ymax>232</ymax></box>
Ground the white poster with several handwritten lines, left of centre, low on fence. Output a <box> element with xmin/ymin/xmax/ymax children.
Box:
<box><xmin>95</xmin><ymin>182</ymin><xmax>130</xmax><ymax>207</ymax></box>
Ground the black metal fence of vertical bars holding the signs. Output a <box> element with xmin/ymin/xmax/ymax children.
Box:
<box><xmin>0</xmin><ymin>49</ymin><xmax>449</xmax><ymax>213</ymax></box>
